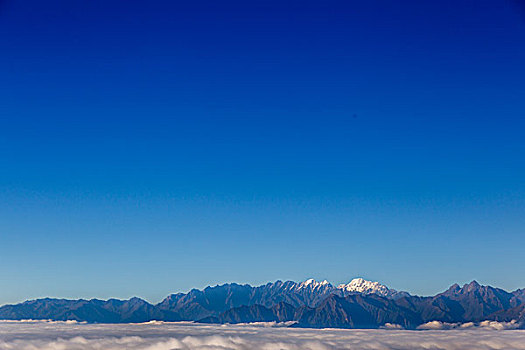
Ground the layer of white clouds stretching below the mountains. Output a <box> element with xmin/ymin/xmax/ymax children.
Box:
<box><xmin>0</xmin><ymin>321</ymin><xmax>525</xmax><ymax>350</ymax></box>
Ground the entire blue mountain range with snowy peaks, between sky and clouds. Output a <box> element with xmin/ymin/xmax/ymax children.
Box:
<box><xmin>0</xmin><ymin>278</ymin><xmax>525</xmax><ymax>329</ymax></box>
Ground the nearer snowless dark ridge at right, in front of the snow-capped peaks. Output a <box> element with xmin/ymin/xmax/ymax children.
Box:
<box><xmin>202</xmin><ymin>282</ymin><xmax>525</xmax><ymax>328</ymax></box>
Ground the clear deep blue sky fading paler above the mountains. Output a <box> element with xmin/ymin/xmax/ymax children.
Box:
<box><xmin>0</xmin><ymin>0</ymin><xmax>525</xmax><ymax>304</ymax></box>
